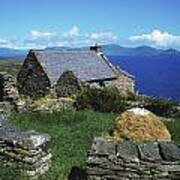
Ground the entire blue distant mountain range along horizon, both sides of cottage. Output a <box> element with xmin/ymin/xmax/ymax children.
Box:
<box><xmin>0</xmin><ymin>44</ymin><xmax>180</xmax><ymax>58</ymax></box>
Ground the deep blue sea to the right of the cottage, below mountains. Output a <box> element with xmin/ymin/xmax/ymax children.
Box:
<box><xmin>109</xmin><ymin>55</ymin><xmax>180</xmax><ymax>100</ymax></box>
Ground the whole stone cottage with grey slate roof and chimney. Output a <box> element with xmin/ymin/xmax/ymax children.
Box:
<box><xmin>17</xmin><ymin>46</ymin><xmax>134</xmax><ymax>97</ymax></box>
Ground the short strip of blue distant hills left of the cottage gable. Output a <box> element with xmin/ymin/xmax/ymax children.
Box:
<box><xmin>0</xmin><ymin>48</ymin><xmax>27</xmax><ymax>59</ymax></box>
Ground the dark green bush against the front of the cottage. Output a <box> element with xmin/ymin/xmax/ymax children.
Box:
<box><xmin>76</xmin><ymin>87</ymin><xmax>126</xmax><ymax>113</ymax></box>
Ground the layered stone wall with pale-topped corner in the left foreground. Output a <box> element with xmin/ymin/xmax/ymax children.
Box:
<box><xmin>0</xmin><ymin>114</ymin><xmax>51</xmax><ymax>176</ymax></box>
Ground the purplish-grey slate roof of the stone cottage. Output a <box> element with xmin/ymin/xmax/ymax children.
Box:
<box><xmin>33</xmin><ymin>50</ymin><xmax>117</xmax><ymax>84</ymax></box>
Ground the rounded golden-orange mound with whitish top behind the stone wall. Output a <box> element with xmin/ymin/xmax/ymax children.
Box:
<box><xmin>111</xmin><ymin>108</ymin><xmax>171</xmax><ymax>142</ymax></box>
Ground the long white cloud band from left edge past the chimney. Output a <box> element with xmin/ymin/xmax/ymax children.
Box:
<box><xmin>0</xmin><ymin>26</ymin><xmax>117</xmax><ymax>49</ymax></box>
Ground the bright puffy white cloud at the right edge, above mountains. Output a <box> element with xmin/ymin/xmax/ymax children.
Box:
<box><xmin>129</xmin><ymin>30</ymin><xmax>180</xmax><ymax>48</ymax></box>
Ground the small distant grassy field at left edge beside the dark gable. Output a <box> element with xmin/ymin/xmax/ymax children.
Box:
<box><xmin>0</xmin><ymin>59</ymin><xmax>23</xmax><ymax>76</ymax></box>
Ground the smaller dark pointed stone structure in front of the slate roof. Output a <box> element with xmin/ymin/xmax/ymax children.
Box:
<box><xmin>55</xmin><ymin>71</ymin><xmax>82</xmax><ymax>97</ymax></box>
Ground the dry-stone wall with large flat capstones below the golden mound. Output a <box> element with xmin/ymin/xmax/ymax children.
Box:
<box><xmin>87</xmin><ymin>138</ymin><xmax>180</xmax><ymax>180</ymax></box>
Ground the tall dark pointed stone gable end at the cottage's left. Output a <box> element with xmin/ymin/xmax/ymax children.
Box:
<box><xmin>17</xmin><ymin>52</ymin><xmax>51</xmax><ymax>98</ymax></box>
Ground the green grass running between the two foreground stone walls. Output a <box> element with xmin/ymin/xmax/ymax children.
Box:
<box><xmin>0</xmin><ymin>110</ymin><xmax>115</xmax><ymax>180</ymax></box>
